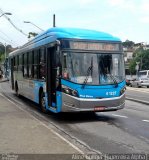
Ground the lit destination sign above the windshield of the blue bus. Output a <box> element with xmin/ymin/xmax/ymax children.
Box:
<box><xmin>69</xmin><ymin>41</ymin><xmax>120</xmax><ymax>51</ymax></box>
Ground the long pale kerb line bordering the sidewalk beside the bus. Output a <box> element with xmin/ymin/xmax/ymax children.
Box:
<box><xmin>0</xmin><ymin>93</ymin><xmax>84</xmax><ymax>154</ymax></box>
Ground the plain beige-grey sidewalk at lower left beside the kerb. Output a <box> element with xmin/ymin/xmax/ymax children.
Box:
<box><xmin>0</xmin><ymin>93</ymin><xmax>79</xmax><ymax>154</ymax></box>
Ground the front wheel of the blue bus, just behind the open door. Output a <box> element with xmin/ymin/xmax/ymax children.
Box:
<box><xmin>39</xmin><ymin>92</ymin><xmax>47</xmax><ymax>113</ymax></box>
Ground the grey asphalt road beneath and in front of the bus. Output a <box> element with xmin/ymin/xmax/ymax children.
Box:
<box><xmin>0</xmin><ymin>82</ymin><xmax>149</xmax><ymax>154</ymax></box>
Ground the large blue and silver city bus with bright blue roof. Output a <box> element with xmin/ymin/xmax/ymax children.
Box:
<box><xmin>9</xmin><ymin>27</ymin><xmax>125</xmax><ymax>113</ymax></box>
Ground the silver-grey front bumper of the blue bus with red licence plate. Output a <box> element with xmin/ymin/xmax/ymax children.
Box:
<box><xmin>61</xmin><ymin>93</ymin><xmax>125</xmax><ymax>112</ymax></box>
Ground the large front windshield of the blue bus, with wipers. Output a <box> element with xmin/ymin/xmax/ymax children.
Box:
<box><xmin>62</xmin><ymin>52</ymin><xmax>125</xmax><ymax>85</ymax></box>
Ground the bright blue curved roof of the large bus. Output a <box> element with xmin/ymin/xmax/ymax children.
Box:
<box><xmin>9</xmin><ymin>27</ymin><xmax>121</xmax><ymax>56</ymax></box>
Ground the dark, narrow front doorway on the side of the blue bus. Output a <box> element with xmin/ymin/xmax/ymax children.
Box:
<box><xmin>46</xmin><ymin>47</ymin><xmax>56</xmax><ymax>107</ymax></box>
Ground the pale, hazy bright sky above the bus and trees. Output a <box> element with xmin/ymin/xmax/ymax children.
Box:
<box><xmin>0</xmin><ymin>0</ymin><xmax>149</xmax><ymax>47</ymax></box>
